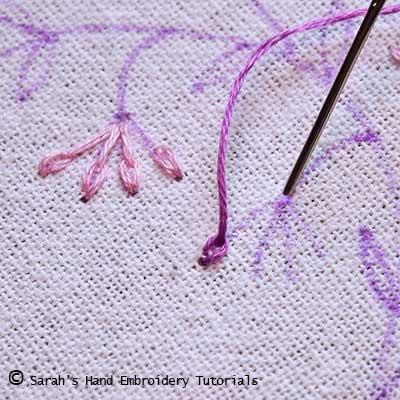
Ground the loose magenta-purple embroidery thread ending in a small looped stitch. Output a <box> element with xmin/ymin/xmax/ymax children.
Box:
<box><xmin>199</xmin><ymin>4</ymin><xmax>400</xmax><ymax>267</ymax></box>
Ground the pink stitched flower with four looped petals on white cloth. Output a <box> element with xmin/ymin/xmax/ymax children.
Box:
<box><xmin>39</xmin><ymin>113</ymin><xmax>183</xmax><ymax>201</ymax></box>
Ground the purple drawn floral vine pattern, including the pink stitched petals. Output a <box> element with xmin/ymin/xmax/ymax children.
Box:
<box><xmin>0</xmin><ymin>0</ymin><xmax>400</xmax><ymax>399</ymax></box>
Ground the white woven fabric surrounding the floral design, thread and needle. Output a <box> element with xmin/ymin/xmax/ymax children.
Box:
<box><xmin>0</xmin><ymin>0</ymin><xmax>400</xmax><ymax>400</ymax></box>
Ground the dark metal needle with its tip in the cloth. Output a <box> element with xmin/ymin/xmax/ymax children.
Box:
<box><xmin>283</xmin><ymin>0</ymin><xmax>386</xmax><ymax>196</ymax></box>
